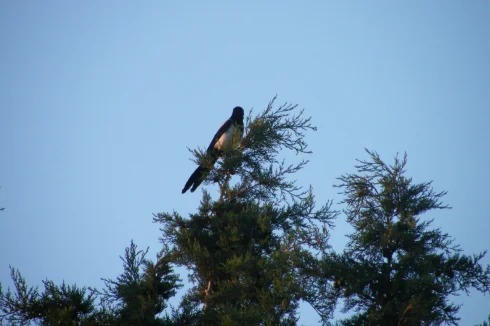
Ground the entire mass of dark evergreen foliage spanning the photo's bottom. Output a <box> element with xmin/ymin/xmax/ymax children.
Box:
<box><xmin>0</xmin><ymin>98</ymin><xmax>490</xmax><ymax>326</ymax></box>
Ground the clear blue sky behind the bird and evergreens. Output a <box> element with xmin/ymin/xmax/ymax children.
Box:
<box><xmin>0</xmin><ymin>0</ymin><xmax>490</xmax><ymax>325</ymax></box>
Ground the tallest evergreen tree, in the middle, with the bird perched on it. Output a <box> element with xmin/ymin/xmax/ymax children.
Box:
<box><xmin>155</xmin><ymin>100</ymin><xmax>335</xmax><ymax>325</ymax></box>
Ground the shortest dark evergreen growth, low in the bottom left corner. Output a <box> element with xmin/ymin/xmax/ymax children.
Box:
<box><xmin>0</xmin><ymin>242</ymin><xmax>179</xmax><ymax>326</ymax></box>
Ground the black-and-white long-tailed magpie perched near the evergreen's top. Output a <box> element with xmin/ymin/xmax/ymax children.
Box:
<box><xmin>182</xmin><ymin>106</ymin><xmax>245</xmax><ymax>193</ymax></box>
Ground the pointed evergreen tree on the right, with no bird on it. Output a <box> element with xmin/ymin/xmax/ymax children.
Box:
<box><xmin>316</xmin><ymin>151</ymin><xmax>490</xmax><ymax>325</ymax></box>
